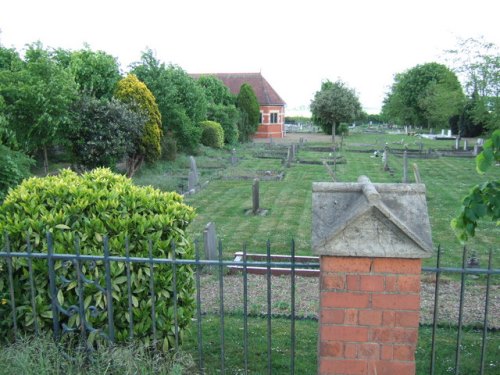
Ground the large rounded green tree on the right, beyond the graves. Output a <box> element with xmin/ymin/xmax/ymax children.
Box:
<box><xmin>383</xmin><ymin>62</ymin><xmax>465</xmax><ymax>128</ymax></box>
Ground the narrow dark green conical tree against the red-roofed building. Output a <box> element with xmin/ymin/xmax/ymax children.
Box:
<box><xmin>236</xmin><ymin>83</ymin><xmax>260</xmax><ymax>142</ymax></box>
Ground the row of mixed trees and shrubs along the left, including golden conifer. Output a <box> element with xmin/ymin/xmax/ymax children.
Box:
<box><xmin>0</xmin><ymin>42</ymin><xmax>259</xmax><ymax>200</ymax></box>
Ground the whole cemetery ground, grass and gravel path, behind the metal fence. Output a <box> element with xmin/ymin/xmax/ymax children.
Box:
<box><xmin>6</xmin><ymin>133</ymin><xmax>500</xmax><ymax>374</ymax></box>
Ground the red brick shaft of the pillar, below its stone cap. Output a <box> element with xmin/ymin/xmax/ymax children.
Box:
<box><xmin>318</xmin><ymin>256</ymin><xmax>421</xmax><ymax>375</ymax></box>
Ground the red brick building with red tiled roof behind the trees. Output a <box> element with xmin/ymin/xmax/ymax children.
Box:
<box><xmin>191</xmin><ymin>73</ymin><xmax>286</xmax><ymax>138</ymax></box>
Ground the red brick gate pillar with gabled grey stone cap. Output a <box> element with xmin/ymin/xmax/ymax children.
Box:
<box><xmin>312</xmin><ymin>176</ymin><xmax>432</xmax><ymax>375</ymax></box>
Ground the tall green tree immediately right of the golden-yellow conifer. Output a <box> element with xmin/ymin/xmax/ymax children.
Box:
<box><xmin>132</xmin><ymin>49</ymin><xmax>207</xmax><ymax>151</ymax></box>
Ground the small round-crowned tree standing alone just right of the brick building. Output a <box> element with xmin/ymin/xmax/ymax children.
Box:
<box><xmin>311</xmin><ymin>80</ymin><xmax>361</xmax><ymax>138</ymax></box>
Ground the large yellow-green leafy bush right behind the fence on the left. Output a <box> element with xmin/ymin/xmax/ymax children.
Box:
<box><xmin>0</xmin><ymin>169</ymin><xmax>195</xmax><ymax>349</ymax></box>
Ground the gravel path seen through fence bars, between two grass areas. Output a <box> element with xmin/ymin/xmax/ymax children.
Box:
<box><xmin>201</xmin><ymin>275</ymin><xmax>500</xmax><ymax>329</ymax></box>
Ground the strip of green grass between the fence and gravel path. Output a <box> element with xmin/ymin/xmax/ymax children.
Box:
<box><xmin>183</xmin><ymin>315</ymin><xmax>500</xmax><ymax>375</ymax></box>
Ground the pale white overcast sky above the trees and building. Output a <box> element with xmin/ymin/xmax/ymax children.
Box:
<box><xmin>0</xmin><ymin>0</ymin><xmax>500</xmax><ymax>115</ymax></box>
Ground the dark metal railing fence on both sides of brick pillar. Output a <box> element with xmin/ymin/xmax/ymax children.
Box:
<box><xmin>0</xmin><ymin>235</ymin><xmax>500</xmax><ymax>374</ymax></box>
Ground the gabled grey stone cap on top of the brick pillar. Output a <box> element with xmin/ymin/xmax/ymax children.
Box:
<box><xmin>312</xmin><ymin>176</ymin><xmax>433</xmax><ymax>258</ymax></box>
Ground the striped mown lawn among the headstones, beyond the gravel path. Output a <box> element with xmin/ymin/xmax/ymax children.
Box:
<box><xmin>135</xmin><ymin>133</ymin><xmax>500</xmax><ymax>268</ymax></box>
